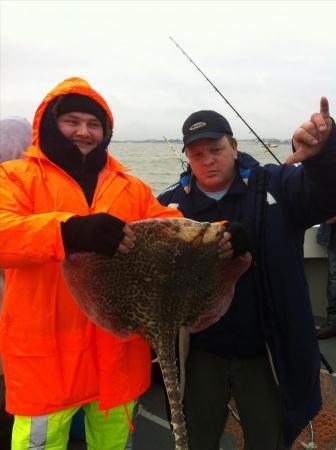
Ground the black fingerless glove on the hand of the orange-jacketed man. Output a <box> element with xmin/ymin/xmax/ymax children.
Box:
<box><xmin>61</xmin><ymin>213</ymin><xmax>125</xmax><ymax>256</ymax></box>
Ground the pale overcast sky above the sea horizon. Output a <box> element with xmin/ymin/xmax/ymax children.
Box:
<box><xmin>0</xmin><ymin>0</ymin><xmax>336</xmax><ymax>139</ymax></box>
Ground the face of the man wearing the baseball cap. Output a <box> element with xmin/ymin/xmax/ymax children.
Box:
<box><xmin>186</xmin><ymin>136</ymin><xmax>238</xmax><ymax>192</ymax></box>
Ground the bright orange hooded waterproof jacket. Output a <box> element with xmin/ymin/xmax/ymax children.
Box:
<box><xmin>0</xmin><ymin>78</ymin><xmax>181</xmax><ymax>416</ymax></box>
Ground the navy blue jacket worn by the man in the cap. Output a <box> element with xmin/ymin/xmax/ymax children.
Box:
<box><xmin>158</xmin><ymin>124</ymin><xmax>336</xmax><ymax>444</ymax></box>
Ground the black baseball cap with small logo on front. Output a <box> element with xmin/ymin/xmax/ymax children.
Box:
<box><xmin>182</xmin><ymin>110</ymin><xmax>233</xmax><ymax>152</ymax></box>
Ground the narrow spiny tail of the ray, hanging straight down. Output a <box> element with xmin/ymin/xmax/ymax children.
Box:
<box><xmin>155</xmin><ymin>340</ymin><xmax>189</xmax><ymax>450</ymax></box>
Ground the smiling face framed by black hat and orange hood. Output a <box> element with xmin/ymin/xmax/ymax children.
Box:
<box><xmin>57</xmin><ymin>112</ymin><xmax>104</xmax><ymax>155</ymax></box>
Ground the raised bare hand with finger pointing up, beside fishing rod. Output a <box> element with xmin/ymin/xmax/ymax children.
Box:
<box><xmin>286</xmin><ymin>97</ymin><xmax>332</xmax><ymax>164</ymax></box>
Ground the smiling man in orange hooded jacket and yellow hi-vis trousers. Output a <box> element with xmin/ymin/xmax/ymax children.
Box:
<box><xmin>0</xmin><ymin>78</ymin><xmax>186</xmax><ymax>450</ymax></box>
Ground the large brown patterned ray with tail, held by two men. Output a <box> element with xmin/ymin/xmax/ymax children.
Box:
<box><xmin>63</xmin><ymin>219</ymin><xmax>250</xmax><ymax>450</ymax></box>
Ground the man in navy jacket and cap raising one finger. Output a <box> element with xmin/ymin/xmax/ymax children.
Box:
<box><xmin>159</xmin><ymin>97</ymin><xmax>336</xmax><ymax>450</ymax></box>
